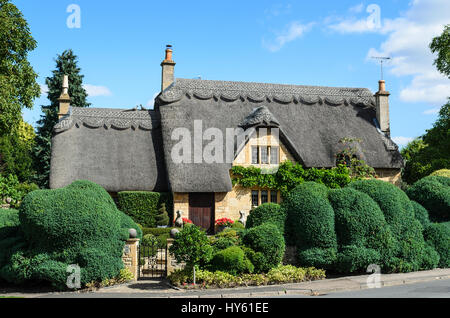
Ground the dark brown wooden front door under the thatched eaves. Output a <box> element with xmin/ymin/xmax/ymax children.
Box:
<box><xmin>189</xmin><ymin>192</ymin><xmax>214</xmax><ymax>232</ymax></box>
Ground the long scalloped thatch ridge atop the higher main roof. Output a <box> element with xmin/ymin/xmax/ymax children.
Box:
<box><xmin>158</xmin><ymin>78</ymin><xmax>375</xmax><ymax>107</ymax></box>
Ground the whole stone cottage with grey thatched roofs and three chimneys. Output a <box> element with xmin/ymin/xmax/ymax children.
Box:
<box><xmin>50</xmin><ymin>47</ymin><xmax>402</xmax><ymax>228</ymax></box>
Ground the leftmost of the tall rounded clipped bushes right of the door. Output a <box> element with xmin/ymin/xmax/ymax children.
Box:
<box><xmin>282</xmin><ymin>182</ymin><xmax>337</xmax><ymax>260</ymax></box>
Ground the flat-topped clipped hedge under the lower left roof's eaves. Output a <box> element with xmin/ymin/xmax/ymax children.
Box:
<box><xmin>117</xmin><ymin>191</ymin><xmax>173</xmax><ymax>227</ymax></box>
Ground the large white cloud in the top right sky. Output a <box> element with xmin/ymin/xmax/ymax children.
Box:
<box><xmin>328</xmin><ymin>0</ymin><xmax>450</xmax><ymax>105</ymax></box>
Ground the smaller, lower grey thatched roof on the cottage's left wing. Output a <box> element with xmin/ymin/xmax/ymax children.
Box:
<box><xmin>50</xmin><ymin>107</ymin><xmax>167</xmax><ymax>192</ymax></box>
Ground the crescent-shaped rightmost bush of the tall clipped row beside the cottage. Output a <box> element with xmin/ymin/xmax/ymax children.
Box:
<box><xmin>349</xmin><ymin>179</ymin><xmax>425</xmax><ymax>271</ymax></box>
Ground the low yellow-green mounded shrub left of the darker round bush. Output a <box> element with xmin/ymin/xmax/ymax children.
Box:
<box><xmin>210</xmin><ymin>246</ymin><xmax>254</xmax><ymax>275</ymax></box>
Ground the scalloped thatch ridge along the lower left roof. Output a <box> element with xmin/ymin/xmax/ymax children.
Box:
<box><xmin>53</xmin><ymin>107</ymin><xmax>160</xmax><ymax>133</ymax></box>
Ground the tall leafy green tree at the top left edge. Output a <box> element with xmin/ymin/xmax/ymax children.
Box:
<box><xmin>0</xmin><ymin>0</ymin><xmax>40</xmax><ymax>136</ymax></box>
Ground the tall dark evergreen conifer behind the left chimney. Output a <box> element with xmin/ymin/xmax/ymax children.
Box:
<box><xmin>33</xmin><ymin>50</ymin><xmax>90</xmax><ymax>188</ymax></box>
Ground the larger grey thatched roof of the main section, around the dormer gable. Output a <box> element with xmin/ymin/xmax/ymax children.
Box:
<box><xmin>156</xmin><ymin>79</ymin><xmax>402</xmax><ymax>192</ymax></box>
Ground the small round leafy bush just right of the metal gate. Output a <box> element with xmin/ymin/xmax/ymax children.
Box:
<box><xmin>169</xmin><ymin>225</ymin><xmax>213</xmax><ymax>269</ymax></box>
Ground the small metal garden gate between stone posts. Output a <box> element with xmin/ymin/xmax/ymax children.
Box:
<box><xmin>138</xmin><ymin>242</ymin><xmax>167</xmax><ymax>278</ymax></box>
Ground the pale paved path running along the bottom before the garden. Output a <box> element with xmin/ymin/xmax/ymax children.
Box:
<box><xmin>0</xmin><ymin>268</ymin><xmax>450</xmax><ymax>298</ymax></box>
